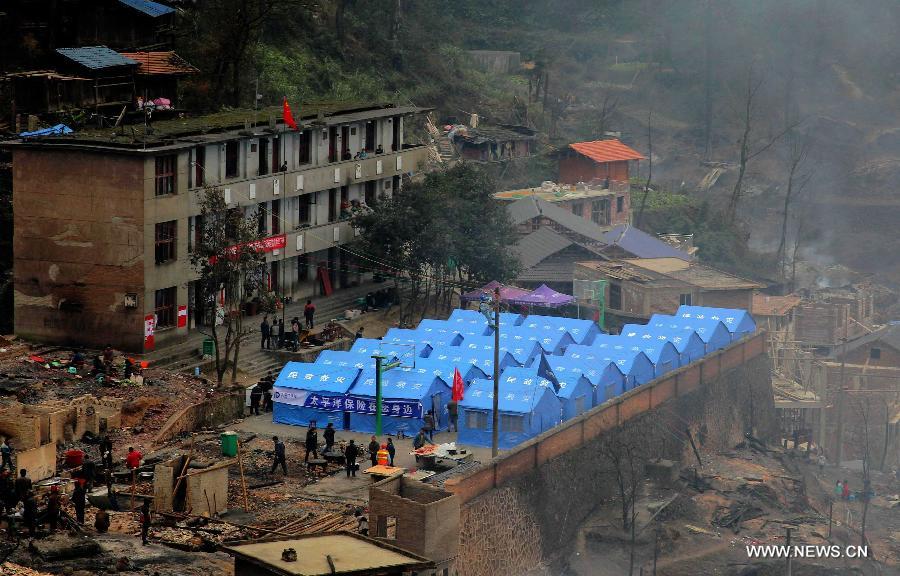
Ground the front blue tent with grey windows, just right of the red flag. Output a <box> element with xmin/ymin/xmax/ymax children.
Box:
<box><xmin>456</xmin><ymin>380</ymin><xmax>560</xmax><ymax>450</ymax></box>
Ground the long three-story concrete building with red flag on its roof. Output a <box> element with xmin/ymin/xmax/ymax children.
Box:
<box><xmin>5</xmin><ymin>105</ymin><xmax>427</xmax><ymax>351</ymax></box>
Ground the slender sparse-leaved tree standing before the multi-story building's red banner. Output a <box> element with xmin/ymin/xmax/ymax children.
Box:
<box><xmin>191</xmin><ymin>186</ymin><xmax>265</xmax><ymax>386</ymax></box>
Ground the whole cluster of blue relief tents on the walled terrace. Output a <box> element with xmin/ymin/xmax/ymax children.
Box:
<box><xmin>273</xmin><ymin>306</ymin><xmax>756</xmax><ymax>449</ymax></box>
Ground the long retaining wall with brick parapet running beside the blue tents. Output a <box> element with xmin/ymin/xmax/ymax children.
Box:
<box><xmin>445</xmin><ymin>332</ymin><xmax>778</xmax><ymax>576</ymax></box>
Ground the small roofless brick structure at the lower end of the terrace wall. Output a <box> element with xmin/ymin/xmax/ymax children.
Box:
<box><xmin>369</xmin><ymin>475</ymin><xmax>459</xmax><ymax>570</ymax></box>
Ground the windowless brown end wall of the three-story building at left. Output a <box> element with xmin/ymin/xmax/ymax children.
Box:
<box><xmin>13</xmin><ymin>150</ymin><xmax>144</xmax><ymax>351</ymax></box>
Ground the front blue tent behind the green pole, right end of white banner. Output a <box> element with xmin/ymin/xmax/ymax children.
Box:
<box><xmin>347</xmin><ymin>368</ymin><xmax>452</xmax><ymax>435</ymax></box>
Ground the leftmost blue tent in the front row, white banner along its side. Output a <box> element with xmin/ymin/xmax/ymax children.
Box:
<box><xmin>272</xmin><ymin>362</ymin><xmax>360</xmax><ymax>428</ymax></box>
